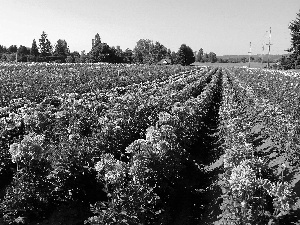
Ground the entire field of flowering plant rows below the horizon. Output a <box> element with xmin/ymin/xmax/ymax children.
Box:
<box><xmin>0</xmin><ymin>63</ymin><xmax>300</xmax><ymax>225</ymax></box>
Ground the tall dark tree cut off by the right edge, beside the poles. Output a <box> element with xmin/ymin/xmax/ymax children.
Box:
<box><xmin>288</xmin><ymin>11</ymin><xmax>300</xmax><ymax>68</ymax></box>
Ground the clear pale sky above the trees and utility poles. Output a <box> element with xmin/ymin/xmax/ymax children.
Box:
<box><xmin>0</xmin><ymin>0</ymin><xmax>300</xmax><ymax>55</ymax></box>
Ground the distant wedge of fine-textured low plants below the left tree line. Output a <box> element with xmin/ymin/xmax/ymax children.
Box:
<box><xmin>0</xmin><ymin>64</ymin><xmax>200</xmax><ymax>107</ymax></box>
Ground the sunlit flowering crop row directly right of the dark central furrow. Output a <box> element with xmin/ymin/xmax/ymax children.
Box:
<box><xmin>220</xmin><ymin>70</ymin><xmax>295</xmax><ymax>224</ymax></box>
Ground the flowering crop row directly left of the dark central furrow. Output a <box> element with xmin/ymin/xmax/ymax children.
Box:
<box><xmin>85</xmin><ymin>67</ymin><xmax>221</xmax><ymax>224</ymax></box>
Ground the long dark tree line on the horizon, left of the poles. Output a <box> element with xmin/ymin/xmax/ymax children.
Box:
<box><xmin>0</xmin><ymin>31</ymin><xmax>217</xmax><ymax>65</ymax></box>
